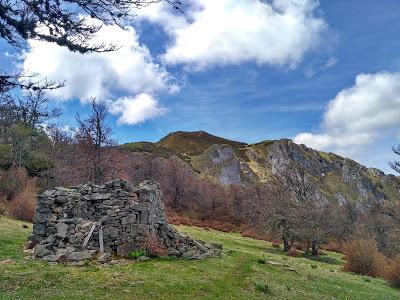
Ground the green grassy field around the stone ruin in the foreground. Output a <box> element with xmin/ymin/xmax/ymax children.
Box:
<box><xmin>0</xmin><ymin>217</ymin><xmax>400</xmax><ymax>300</ymax></box>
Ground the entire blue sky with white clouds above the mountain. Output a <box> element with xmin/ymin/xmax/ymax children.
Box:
<box><xmin>0</xmin><ymin>0</ymin><xmax>400</xmax><ymax>173</ymax></box>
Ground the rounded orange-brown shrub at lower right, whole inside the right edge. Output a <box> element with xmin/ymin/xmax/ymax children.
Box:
<box><xmin>343</xmin><ymin>237</ymin><xmax>388</xmax><ymax>277</ymax></box>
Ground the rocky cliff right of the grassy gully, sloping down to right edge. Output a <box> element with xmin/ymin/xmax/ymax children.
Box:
<box><xmin>246</xmin><ymin>139</ymin><xmax>400</xmax><ymax>204</ymax></box>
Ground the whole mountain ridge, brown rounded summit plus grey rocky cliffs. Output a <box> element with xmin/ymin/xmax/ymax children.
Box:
<box><xmin>123</xmin><ymin>131</ymin><xmax>400</xmax><ymax>203</ymax></box>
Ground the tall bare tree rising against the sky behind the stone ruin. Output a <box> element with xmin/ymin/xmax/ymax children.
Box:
<box><xmin>75</xmin><ymin>98</ymin><xmax>115</xmax><ymax>184</ymax></box>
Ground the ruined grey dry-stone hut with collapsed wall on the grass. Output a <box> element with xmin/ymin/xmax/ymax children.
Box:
<box><xmin>28</xmin><ymin>180</ymin><xmax>221</xmax><ymax>264</ymax></box>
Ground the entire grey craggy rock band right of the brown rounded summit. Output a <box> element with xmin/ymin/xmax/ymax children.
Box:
<box><xmin>191</xmin><ymin>139</ymin><xmax>400</xmax><ymax>208</ymax></box>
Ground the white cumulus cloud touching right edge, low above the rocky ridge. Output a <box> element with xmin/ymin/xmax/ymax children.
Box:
<box><xmin>294</xmin><ymin>72</ymin><xmax>400</xmax><ymax>153</ymax></box>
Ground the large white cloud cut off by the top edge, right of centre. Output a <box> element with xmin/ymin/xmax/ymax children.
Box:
<box><xmin>140</xmin><ymin>0</ymin><xmax>328</xmax><ymax>69</ymax></box>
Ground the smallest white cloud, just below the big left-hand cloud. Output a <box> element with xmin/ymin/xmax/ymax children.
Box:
<box><xmin>110</xmin><ymin>94</ymin><xmax>168</xmax><ymax>125</ymax></box>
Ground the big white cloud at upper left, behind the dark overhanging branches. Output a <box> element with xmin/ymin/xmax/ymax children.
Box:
<box><xmin>23</xmin><ymin>21</ymin><xmax>178</xmax><ymax>101</ymax></box>
